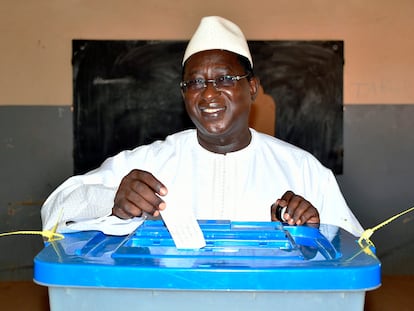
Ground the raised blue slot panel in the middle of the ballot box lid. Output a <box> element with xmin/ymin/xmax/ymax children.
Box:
<box><xmin>112</xmin><ymin>221</ymin><xmax>340</xmax><ymax>266</ymax></box>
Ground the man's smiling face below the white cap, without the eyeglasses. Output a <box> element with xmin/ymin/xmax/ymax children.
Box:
<box><xmin>183</xmin><ymin>50</ymin><xmax>257</xmax><ymax>150</ymax></box>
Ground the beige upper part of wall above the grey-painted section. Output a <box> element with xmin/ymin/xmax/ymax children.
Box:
<box><xmin>0</xmin><ymin>0</ymin><xmax>414</xmax><ymax>105</ymax></box>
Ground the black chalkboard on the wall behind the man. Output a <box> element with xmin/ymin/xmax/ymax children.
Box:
<box><xmin>72</xmin><ymin>40</ymin><xmax>344</xmax><ymax>174</ymax></box>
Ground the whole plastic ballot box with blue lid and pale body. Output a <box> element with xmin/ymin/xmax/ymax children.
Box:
<box><xmin>34</xmin><ymin>220</ymin><xmax>381</xmax><ymax>311</ymax></box>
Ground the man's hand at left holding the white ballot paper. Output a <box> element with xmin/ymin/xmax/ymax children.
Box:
<box><xmin>112</xmin><ymin>169</ymin><xmax>167</xmax><ymax>219</ymax></box>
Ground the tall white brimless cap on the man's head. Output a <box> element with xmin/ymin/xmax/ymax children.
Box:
<box><xmin>182</xmin><ymin>16</ymin><xmax>253</xmax><ymax>68</ymax></box>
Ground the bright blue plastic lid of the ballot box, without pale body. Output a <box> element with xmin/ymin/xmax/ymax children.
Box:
<box><xmin>34</xmin><ymin>220</ymin><xmax>381</xmax><ymax>291</ymax></box>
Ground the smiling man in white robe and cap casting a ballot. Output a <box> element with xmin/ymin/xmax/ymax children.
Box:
<box><xmin>42</xmin><ymin>16</ymin><xmax>363</xmax><ymax>235</ymax></box>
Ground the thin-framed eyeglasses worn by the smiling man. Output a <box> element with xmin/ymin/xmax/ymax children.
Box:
<box><xmin>180</xmin><ymin>73</ymin><xmax>250</xmax><ymax>92</ymax></box>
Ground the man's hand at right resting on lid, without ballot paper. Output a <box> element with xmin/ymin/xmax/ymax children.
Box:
<box><xmin>272</xmin><ymin>191</ymin><xmax>320</xmax><ymax>225</ymax></box>
